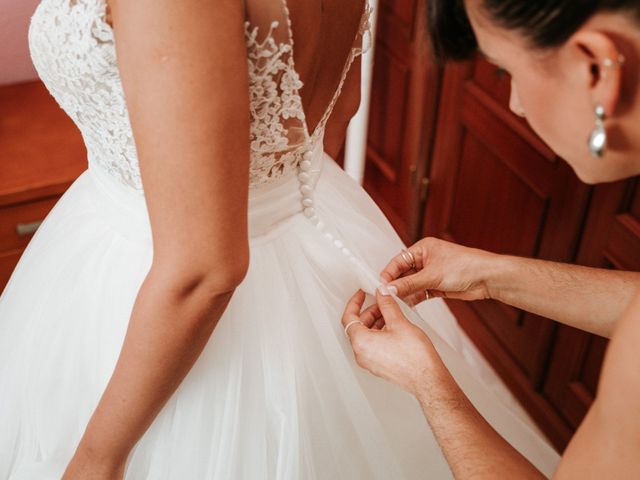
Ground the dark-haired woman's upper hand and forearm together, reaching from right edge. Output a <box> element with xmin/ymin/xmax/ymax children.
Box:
<box><xmin>374</xmin><ymin>238</ymin><xmax>640</xmax><ymax>337</ymax></box>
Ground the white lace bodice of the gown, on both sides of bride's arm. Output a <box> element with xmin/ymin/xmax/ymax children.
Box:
<box><xmin>29</xmin><ymin>0</ymin><xmax>370</xmax><ymax>191</ymax></box>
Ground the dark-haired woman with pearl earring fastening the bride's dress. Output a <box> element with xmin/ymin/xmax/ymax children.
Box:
<box><xmin>343</xmin><ymin>0</ymin><xmax>640</xmax><ymax>479</ymax></box>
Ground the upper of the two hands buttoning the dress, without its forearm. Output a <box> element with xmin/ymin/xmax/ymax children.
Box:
<box><xmin>381</xmin><ymin>238</ymin><xmax>500</xmax><ymax>305</ymax></box>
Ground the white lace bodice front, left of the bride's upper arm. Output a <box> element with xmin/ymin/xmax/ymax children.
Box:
<box><xmin>29</xmin><ymin>0</ymin><xmax>142</xmax><ymax>190</ymax></box>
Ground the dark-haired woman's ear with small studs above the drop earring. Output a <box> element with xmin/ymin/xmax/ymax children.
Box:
<box><xmin>568</xmin><ymin>27</ymin><xmax>624</xmax><ymax>117</ymax></box>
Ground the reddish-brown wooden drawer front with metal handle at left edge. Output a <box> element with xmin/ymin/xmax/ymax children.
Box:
<box><xmin>0</xmin><ymin>196</ymin><xmax>60</xmax><ymax>254</ymax></box>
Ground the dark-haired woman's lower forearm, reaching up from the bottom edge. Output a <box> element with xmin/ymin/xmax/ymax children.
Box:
<box><xmin>417</xmin><ymin>361</ymin><xmax>544</xmax><ymax>480</ymax></box>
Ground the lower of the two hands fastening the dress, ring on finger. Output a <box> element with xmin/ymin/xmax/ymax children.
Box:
<box><xmin>342</xmin><ymin>291</ymin><xmax>441</xmax><ymax>395</ymax></box>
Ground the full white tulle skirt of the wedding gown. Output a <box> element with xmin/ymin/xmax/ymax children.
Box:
<box><xmin>0</xmin><ymin>153</ymin><xmax>558</xmax><ymax>480</ymax></box>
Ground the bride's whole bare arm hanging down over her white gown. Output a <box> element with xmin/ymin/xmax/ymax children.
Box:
<box><xmin>65</xmin><ymin>0</ymin><xmax>249</xmax><ymax>479</ymax></box>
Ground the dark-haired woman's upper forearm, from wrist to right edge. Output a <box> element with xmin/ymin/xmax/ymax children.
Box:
<box><xmin>487</xmin><ymin>256</ymin><xmax>640</xmax><ymax>337</ymax></box>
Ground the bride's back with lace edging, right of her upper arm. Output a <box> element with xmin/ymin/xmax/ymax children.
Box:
<box><xmin>245</xmin><ymin>0</ymin><xmax>369</xmax><ymax>185</ymax></box>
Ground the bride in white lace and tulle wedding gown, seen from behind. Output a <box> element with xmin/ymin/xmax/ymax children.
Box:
<box><xmin>0</xmin><ymin>0</ymin><xmax>557</xmax><ymax>480</ymax></box>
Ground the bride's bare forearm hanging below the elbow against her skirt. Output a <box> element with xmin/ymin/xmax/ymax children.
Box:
<box><xmin>68</xmin><ymin>269</ymin><xmax>242</xmax><ymax>466</ymax></box>
